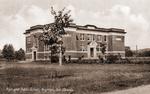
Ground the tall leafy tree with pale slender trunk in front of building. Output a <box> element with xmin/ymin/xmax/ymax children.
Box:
<box><xmin>41</xmin><ymin>7</ymin><xmax>73</xmax><ymax>65</ymax></box>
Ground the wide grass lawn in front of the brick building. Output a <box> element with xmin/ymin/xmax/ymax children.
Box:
<box><xmin>0</xmin><ymin>63</ymin><xmax>150</xmax><ymax>94</ymax></box>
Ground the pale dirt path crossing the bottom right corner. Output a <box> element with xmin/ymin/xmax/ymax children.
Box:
<box><xmin>102</xmin><ymin>85</ymin><xmax>150</xmax><ymax>94</ymax></box>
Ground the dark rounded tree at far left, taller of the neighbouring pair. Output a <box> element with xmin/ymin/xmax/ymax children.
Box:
<box><xmin>2</xmin><ymin>44</ymin><xmax>15</xmax><ymax>61</ymax></box>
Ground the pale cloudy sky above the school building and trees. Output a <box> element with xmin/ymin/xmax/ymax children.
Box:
<box><xmin>0</xmin><ymin>0</ymin><xmax>150</xmax><ymax>50</ymax></box>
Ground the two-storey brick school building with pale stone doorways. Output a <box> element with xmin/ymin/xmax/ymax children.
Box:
<box><xmin>24</xmin><ymin>24</ymin><xmax>126</xmax><ymax>61</ymax></box>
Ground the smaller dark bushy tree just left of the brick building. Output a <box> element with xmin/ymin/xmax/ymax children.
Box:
<box><xmin>15</xmin><ymin>48</ymin><xmax>25</xmax><ymax>60</ymax></box>
